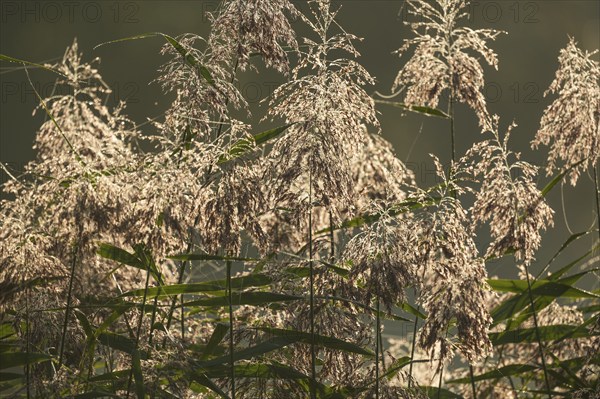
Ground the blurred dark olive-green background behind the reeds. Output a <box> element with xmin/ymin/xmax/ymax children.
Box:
<box><xmin>0</xmin><ymin>0</ymin><xmax>600</xmax><ymax>288</ymax></box>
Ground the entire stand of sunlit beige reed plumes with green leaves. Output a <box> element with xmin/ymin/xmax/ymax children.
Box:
<box><xmin>0</xmin><ymin>0</ymin><xmax>600</xmax><ymax>399</ymax></box>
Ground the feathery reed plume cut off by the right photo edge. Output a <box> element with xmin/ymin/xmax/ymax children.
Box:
<box><xmin>531</xmin><ymin>38</ymin><xmax>600</xmax><ymax>185</ymax></box>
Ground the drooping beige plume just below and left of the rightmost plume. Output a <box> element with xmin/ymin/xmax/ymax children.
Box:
<box><xmin>466</xmin><ymin>116</ymin><xmax>553</xmax><ymax>265</ymax></box>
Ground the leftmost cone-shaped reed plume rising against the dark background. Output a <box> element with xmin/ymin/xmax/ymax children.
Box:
<box><xmin>34</xmin><ymin>39</ymin><xmax>137</xmax><ymax>175</ymax></box>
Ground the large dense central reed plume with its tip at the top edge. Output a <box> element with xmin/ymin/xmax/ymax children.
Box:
<box><xmin>269</xmin><ymin>1</ymin><xmax>378</xmax><ymax>217</ymax></box>
